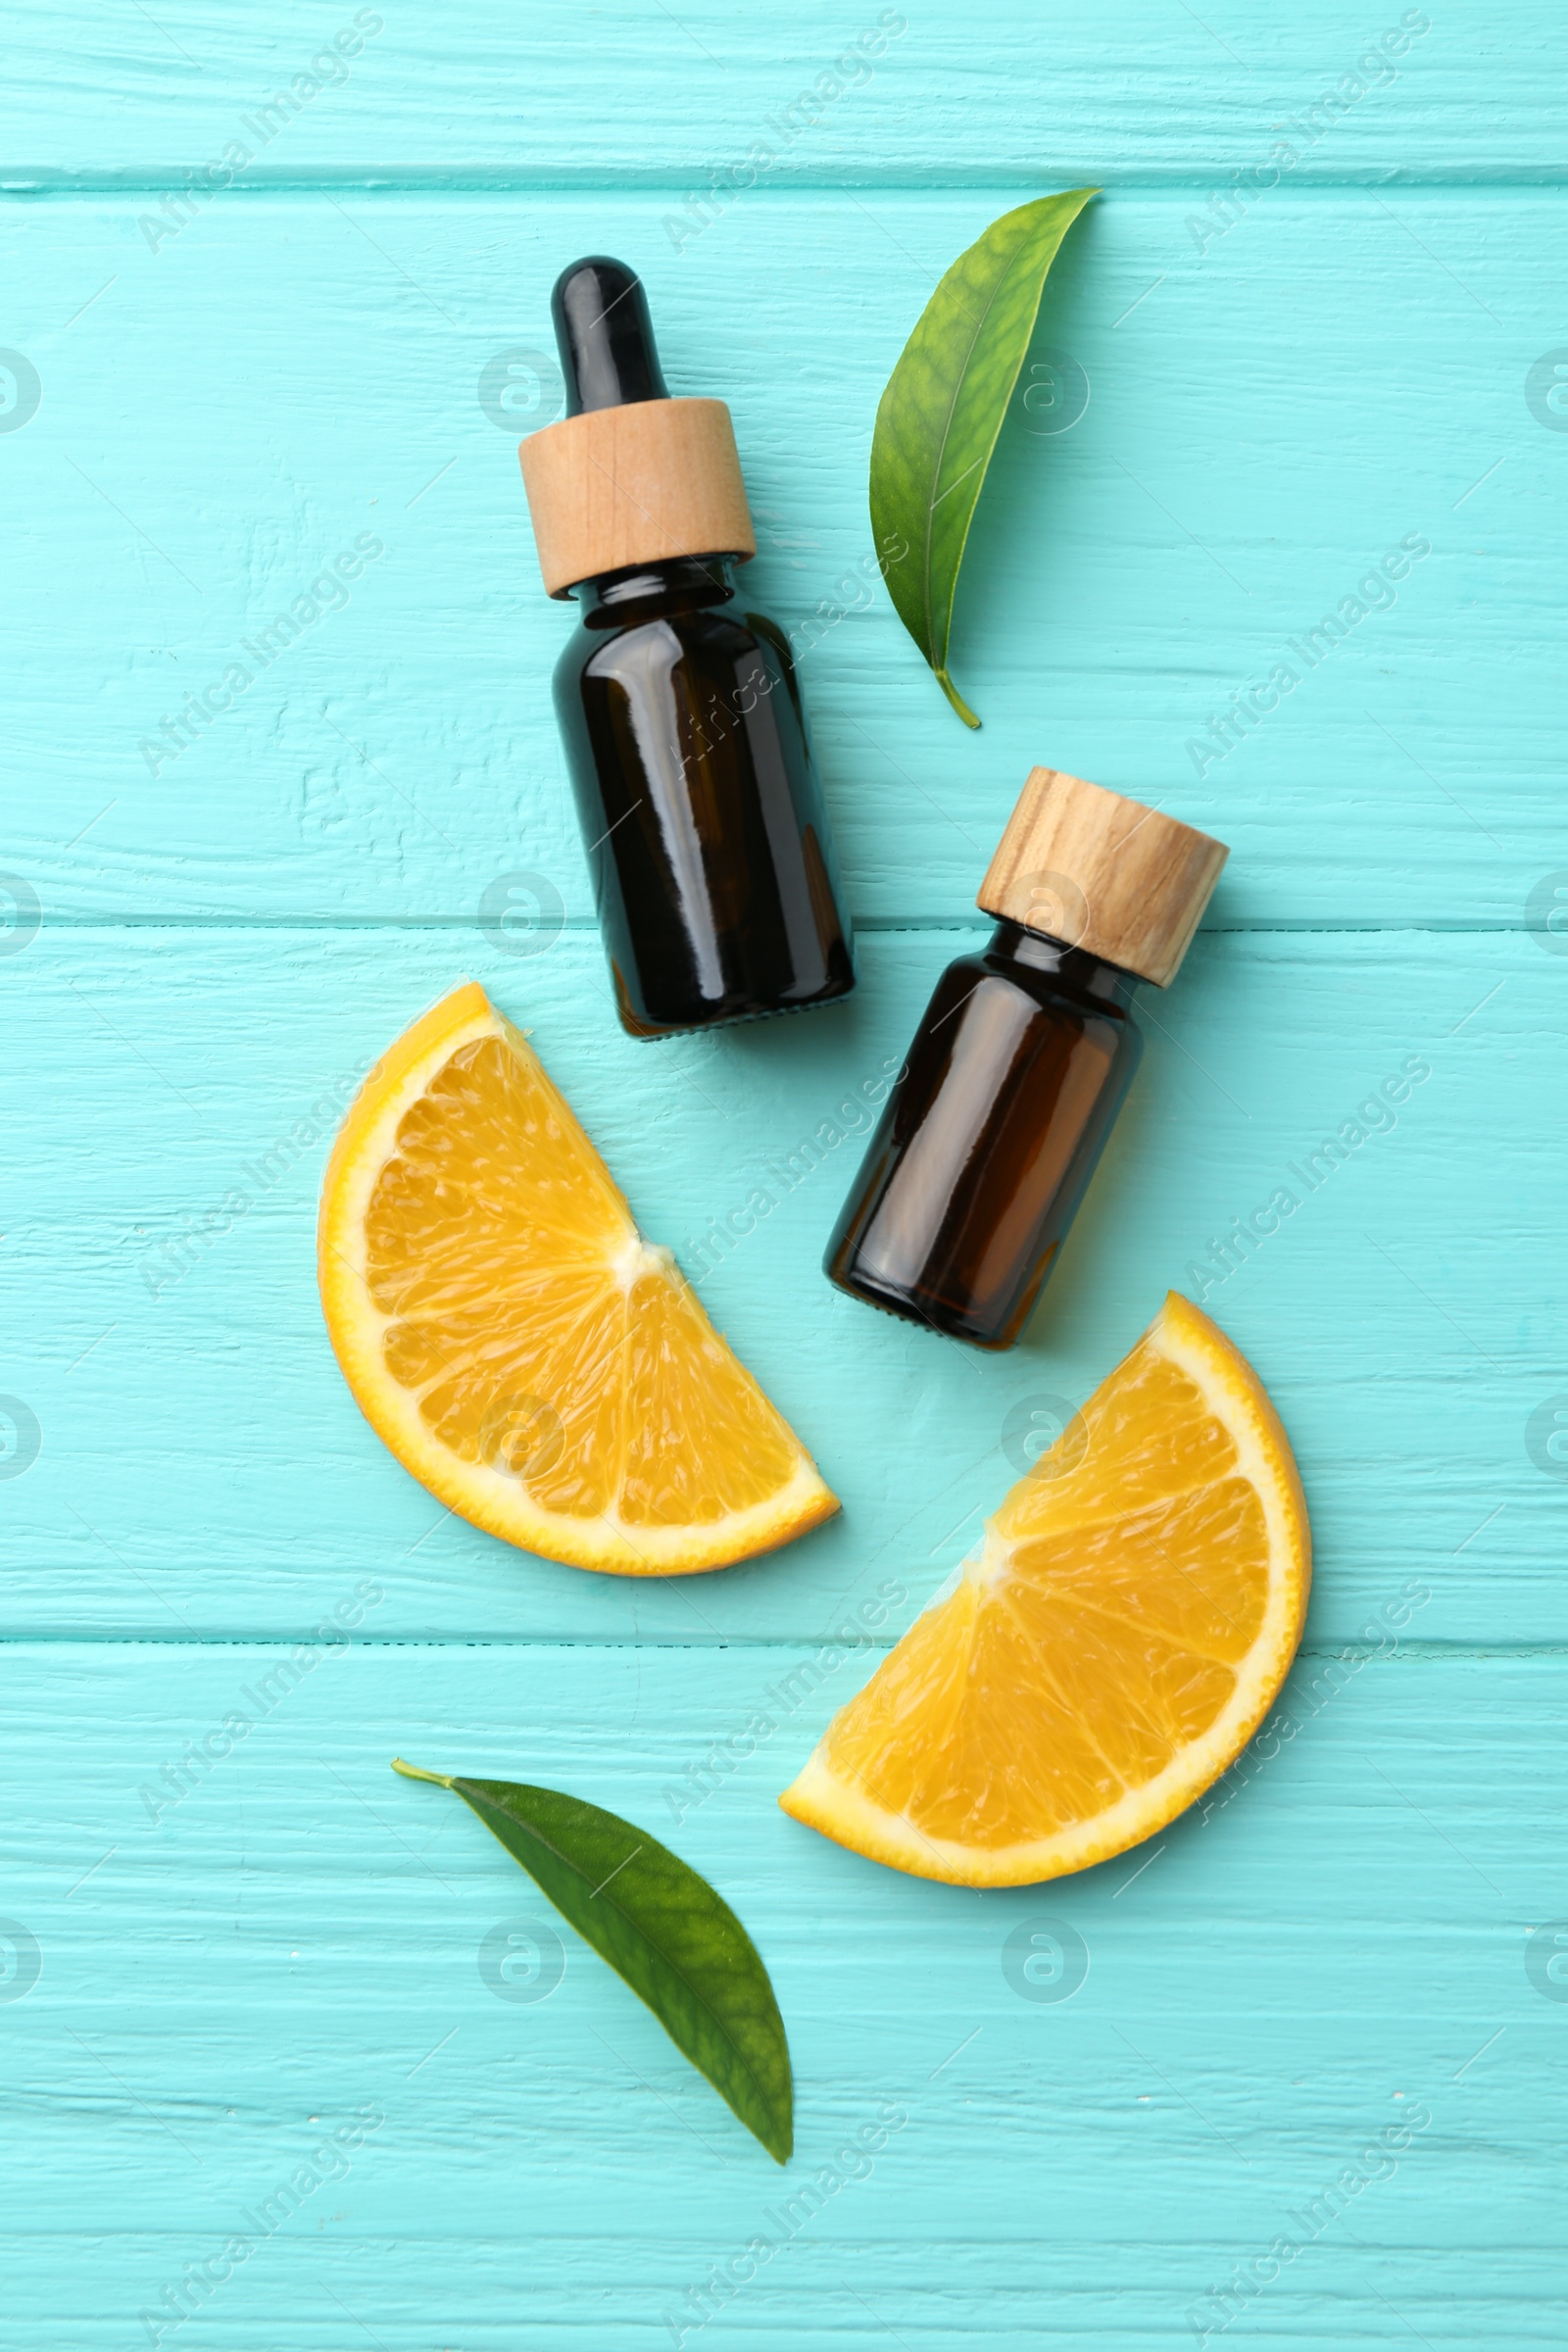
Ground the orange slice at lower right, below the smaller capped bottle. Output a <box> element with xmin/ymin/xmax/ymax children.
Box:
<box><xmin>778</xmin><ymin>1292</ymin><xmax>1309</xmax><ymax>1886</ymax></box>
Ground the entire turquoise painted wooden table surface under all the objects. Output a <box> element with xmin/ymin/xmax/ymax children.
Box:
<box><xmin>0</xmin><ymin>0</ymin><xmax>1568</xmax><ymax>2352</ymax></box>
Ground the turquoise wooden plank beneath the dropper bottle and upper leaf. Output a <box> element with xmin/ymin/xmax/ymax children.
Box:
<box><xmin>0</xmin><ymin>192</ymin><xmax>1568</xmax><ymax>927</ymax></box>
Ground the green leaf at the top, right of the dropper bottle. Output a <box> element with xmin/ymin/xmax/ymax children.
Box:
<box><xmin>872</xmin><ymin>188</ymin><xmax>1101</xmax><ymax>727</ymax></box>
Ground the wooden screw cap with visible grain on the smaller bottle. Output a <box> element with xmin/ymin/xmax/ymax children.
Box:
<box><xmin>976</xmin><ymin>766</ymin><xmax>1230</xmax><ymax>988</ymax></box>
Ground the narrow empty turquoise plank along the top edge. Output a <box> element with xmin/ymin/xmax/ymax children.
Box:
<box><xmin>7</xmin><ymin>0</ymin><xmax>1563</xmax><ymax>190</ymax></box>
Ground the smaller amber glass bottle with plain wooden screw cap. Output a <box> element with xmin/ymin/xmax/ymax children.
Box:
<box><xmin>827</xmin><ymin>766</ymin><xmax>1230</xmax><ymax>1348</ymax></box>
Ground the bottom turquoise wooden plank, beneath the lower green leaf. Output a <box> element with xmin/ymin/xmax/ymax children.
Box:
<box><xmin>0</xmin><ymin>1644</ymin><xmax>1568</xmax><ymax>2352</ymax></box>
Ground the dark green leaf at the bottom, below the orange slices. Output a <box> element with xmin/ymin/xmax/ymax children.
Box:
<box><xmin>393</xmin><ymin>1757</ymin><xmax>795</xmax><ymax>2164</ymax></box>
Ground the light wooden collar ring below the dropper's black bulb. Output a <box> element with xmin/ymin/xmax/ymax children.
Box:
<box><xmin>517</xmin><ymin>400</ymin><xmax>757</xmax><ymax>598</ymax></box>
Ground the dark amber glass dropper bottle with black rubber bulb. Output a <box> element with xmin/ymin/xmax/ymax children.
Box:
<box><xmin>519</xmin><ymin>257</ymin><xmax>856</xmax><ymax>1037</ymax></box>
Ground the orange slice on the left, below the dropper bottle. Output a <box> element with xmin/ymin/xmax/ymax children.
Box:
<box><xmin>318</xmin><ymin>983</ymin><xmax>839</xmax><ymax>1576</ymax></box>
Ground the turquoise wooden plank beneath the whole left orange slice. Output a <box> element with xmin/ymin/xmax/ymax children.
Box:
<box><xmin>0</xmin><ymin>929</ymin><xmax>1568</xmax><ymax>1644</ymax></box>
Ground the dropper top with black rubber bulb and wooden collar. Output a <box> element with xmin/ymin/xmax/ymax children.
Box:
<box><xmin>517</xmin><ymin>254</ymin><xmax>757</xmax><ymax>598</ymax></box>
